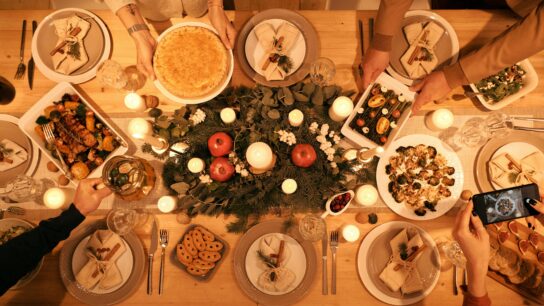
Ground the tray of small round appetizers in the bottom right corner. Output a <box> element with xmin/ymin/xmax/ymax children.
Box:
<box><xmin>487</xmin><ymin>220</ymin><xmax>544</xmax><ymax>304</ymax></box>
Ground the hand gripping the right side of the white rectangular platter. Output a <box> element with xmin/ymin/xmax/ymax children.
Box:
<box><xmin>410</xmin><ymin>71</ymin><xmax>451</xmax><ymax>113</ymax></box>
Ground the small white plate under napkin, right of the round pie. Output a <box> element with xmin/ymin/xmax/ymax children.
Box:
<box><xmin>245</xmin><ymin>19</ymin><xmax>306</xmax><ymax>76</ymax></box>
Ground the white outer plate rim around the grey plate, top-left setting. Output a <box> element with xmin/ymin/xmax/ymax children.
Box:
<box><xmin>32</xmin><ymin>8</ymin><xmax>111</xmax><ymax>84</ymax></box>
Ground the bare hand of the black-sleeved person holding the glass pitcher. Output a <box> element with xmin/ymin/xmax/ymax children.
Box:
<box><xmin>74</xmin><ymin>178</ymin><xmax>112</xmax><ymax>216</ymax></box>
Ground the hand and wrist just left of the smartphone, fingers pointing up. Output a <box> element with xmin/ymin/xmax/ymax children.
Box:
<box><xmin>453</xmin><ymin>201</ymin><xmax>490</xmax><ymax>297</ymax></box>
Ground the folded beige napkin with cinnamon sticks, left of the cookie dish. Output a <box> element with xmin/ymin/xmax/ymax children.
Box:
<box><xmin>76</xmin><ymin>230</ymin><xmax>126</xmax><ymax>290</ymax></box>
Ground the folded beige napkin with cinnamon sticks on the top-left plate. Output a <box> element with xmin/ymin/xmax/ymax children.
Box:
<box><xmin>52</xmin><ymin>15</ymin><xmax>91</xmax><ymax>75</ymax></box>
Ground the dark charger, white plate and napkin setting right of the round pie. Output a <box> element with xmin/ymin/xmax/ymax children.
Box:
<box><xmin>235</xmin><ymin>9</ymin><xmax>319</xmax><ymax>86</ymax></box>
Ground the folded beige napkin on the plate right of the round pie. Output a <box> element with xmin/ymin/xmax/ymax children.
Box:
<box><xmin>255</xmin><ymin>22</ymin><xmax>300</xmax><ymax>81</ymax></box>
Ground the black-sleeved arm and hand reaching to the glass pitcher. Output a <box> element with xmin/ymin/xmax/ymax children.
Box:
<box><xmin>0</xmin><ymin>179</ymin><xmax>111</xmax><ymax>295</ymax></box>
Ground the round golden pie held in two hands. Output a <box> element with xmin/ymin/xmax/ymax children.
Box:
<box><xmin>153</xmin><ymin>26</ymin><xmax>229</xmax><ymax>99</ymax></box>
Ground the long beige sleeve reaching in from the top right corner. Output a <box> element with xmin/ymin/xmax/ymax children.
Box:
<box><xmin>444</xmin><ymin>2</ymin><xmax>544</xmax><ymax>88</ymax></box>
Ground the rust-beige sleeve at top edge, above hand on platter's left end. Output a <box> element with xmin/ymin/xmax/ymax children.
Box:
<box><xmin>372</xmin><ymin>0</ymin><xmax>414</xmax><ymax>51</ymax></box>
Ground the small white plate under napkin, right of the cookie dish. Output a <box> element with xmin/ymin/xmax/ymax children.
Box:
<box><xmin>246</xmin><ymin>233</ymin><xmax>306</xmax><ymax>295</ymax></box>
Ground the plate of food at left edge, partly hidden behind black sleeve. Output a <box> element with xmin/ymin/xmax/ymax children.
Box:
<box><xmin>0</xmin><ymin>218</ymin><xmax>44</xmax><ymax>290</ymax></box>
